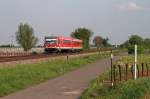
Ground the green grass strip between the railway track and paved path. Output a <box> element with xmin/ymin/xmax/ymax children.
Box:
<box><xmin>0</xmin><ymin>54</ymin><xmax>108</xmax><ymax>97</ymax></box>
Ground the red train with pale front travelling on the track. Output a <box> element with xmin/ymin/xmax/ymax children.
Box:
<box><xmin>44</xmin><ymin>36</ymin><xmax>83</xmax><ymax>52</ymax></box>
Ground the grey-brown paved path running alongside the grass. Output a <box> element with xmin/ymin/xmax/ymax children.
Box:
<box><xmin>0</xmin><ymin>58</ymin><xmax>117</xmax><ymax>99</ymax></box>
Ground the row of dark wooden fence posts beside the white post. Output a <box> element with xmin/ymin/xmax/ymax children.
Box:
<box><xmin>111</xmin><ymin>63</ymin><xmax>150</xmax><ymax>85</ymax></box>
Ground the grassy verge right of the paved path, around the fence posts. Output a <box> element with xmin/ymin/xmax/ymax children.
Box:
<box><xmin>81</xmin><ymin>55</ymin><xmax>150</xmax><ymax>99</ymax></box>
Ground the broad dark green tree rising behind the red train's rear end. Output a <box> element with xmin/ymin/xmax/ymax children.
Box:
<box><xmin>71</xmin><ymin>28</ymin><xmax>93</xmax><ymax>49</ymax></box>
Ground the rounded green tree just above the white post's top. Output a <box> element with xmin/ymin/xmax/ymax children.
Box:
<box><xmin>129</xmin><ymin>35</ymin><xmax>143</xmax><ymax>45</ymax></box>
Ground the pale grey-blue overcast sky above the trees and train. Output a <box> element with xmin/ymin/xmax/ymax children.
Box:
<box><xmin>0</xmin><ymin>0</ymin><xmax>150</xmax><ymax>44</ymax></box>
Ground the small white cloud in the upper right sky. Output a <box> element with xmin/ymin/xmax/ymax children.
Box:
<box><xmin>116</xmin><ymin>2</ymin><xmax>145</xmax><ymax>11</ymax></box>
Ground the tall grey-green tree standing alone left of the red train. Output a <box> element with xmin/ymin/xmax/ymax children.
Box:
<box><xmin>16</xmin><ymin>23</ymin><xmax>38</xmax><ymax>51</ymax></box>
